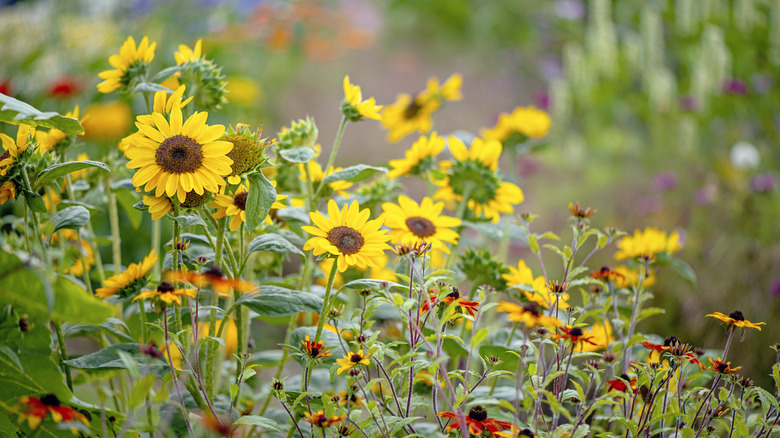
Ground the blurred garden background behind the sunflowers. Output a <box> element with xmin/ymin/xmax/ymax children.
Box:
<box><xmin>0</xmin><ymin>0</ymin><xmax>780</xmax><ymax>384</ymax></box>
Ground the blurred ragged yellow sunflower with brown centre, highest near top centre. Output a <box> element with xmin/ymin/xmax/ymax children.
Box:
<box><xmin>382</xmin><ymin>73</ymin><xmax>463</xmax><ymax>143</ymax></box>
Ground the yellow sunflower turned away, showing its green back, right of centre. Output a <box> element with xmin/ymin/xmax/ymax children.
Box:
<box><xmin>433</xmin><ymin>137</ymin><xmax>524</xmax><ymax>223</ymax></box>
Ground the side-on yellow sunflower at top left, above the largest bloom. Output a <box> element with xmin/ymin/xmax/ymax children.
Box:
<box><xmin>98</xmin><ymin>37</ymin><xmax>157</xmax><ymax>94</ymax></box>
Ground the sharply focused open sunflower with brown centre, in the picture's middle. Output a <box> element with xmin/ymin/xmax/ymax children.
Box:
<box><xmin>301</xmin><ymin>199</ymin><xmax>390</xmax><ymax>272</ymax></box>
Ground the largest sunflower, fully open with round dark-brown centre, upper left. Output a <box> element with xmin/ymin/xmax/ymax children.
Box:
<box><xmin>125</xmin><ymin>105</ymin><xmax>233</xmax><ymax>202</ymax></box>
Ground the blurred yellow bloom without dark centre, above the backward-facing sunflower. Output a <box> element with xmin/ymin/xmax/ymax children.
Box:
<box><xmin>481</xmin><ymin>106</ymin><xmax>551</xmax><ymax>146</ymax></box>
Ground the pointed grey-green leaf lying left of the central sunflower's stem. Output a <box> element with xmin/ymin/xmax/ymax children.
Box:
<box><xmin>236</xmin><ymin>285</ymin><xmax>322</xmax><ymax>317</ymax></box>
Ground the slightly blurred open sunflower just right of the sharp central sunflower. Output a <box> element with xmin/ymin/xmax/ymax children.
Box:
<box><xmin>380</xmin><ymin>195</ymin><xmax>460</xmax><ymax>254</ymax></box>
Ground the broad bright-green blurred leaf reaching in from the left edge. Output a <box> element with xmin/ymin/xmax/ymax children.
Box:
<box><xmin>0</xmin><ymin>250</ymin><xmax>114</xmax><ymax>323</ymax></box>
